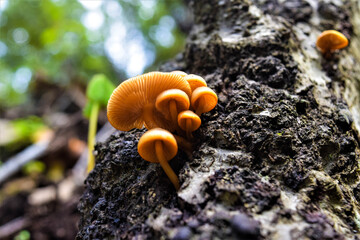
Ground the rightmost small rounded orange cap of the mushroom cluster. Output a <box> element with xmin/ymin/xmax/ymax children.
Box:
<box><xmin>191</xmin><ymin>87</ymin><xmax>218</xmax><ymax>113</ymax></box>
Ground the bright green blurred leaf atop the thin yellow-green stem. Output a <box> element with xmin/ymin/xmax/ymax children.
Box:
<box><xmin>86</xmin><ymin>74</ymin><xmax>115</xmax><ymax>106</ymax></box>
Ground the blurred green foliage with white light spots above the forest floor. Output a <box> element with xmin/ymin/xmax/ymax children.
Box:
<box><xmin>0</xmin><ymin>0</ymin><xmax>184</xmax><ymax>109</ymax></box>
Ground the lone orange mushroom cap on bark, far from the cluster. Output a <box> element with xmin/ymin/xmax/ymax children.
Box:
<box><xmin>316</xmin><ymin>30</ymin><xmax>349</xmax><ymax>52</ymax></box>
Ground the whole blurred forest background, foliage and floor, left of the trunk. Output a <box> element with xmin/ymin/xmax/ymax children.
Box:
<box><xmin>0</xmin><ymin>0</ymin><xmax>191</xmax><ymax>239</ymax></box>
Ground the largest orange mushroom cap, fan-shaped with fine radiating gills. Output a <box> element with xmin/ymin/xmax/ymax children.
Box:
<box><xmin>107</xmin><ymin>72</ymin><xmax>191</xmax><ymax>131</ymax></box>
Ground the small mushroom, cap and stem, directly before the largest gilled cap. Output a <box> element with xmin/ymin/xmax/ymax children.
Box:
<box><xmin>155</xmin><ymin>89</ymin><xmax>190</xmax><ymax>129</ymax></box>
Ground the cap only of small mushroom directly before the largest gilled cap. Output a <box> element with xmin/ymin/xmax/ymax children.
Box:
<box><xmin>155</xmin><ymin>89</ymin><xmax>190</xmax><ymax>119</ymax></box>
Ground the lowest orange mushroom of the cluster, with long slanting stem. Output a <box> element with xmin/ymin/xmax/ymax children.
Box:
<box><xmin>138</xmin><ymin>128</ymin><xmax>180</xmax><ymax>190</ymax></box>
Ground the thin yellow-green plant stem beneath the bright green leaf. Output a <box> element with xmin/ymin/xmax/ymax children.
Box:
<box><xmin>87</xmin><ymin>103</ymin><xmax>100</xmax><ymax>172</ymax></box>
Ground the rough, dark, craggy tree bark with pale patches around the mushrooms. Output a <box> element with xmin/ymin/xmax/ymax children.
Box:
<box><xmin>77</xmin><ymin>0</ymin><xmax>360</xmax><ymax>239</ymax></box>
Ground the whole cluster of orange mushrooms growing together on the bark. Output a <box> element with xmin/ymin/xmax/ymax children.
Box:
<box><xmin>107</xmin><ymin>71</ymin><xmax>218</xmax><ymax>190</ymax></box>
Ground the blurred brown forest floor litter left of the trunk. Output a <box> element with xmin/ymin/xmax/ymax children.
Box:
<box><xmin>0</xmin><ymin>80</ymin><xmax>106</xmax><ymax>240</ymax></box>
